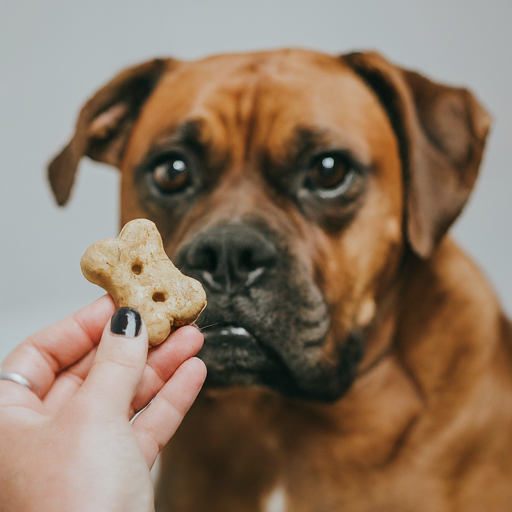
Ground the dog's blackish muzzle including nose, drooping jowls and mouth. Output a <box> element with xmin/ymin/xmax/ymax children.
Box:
<box><xmin>175</xmin><ymin>224</ymin><xmax>362</xmax><ymax>400</ymax></box>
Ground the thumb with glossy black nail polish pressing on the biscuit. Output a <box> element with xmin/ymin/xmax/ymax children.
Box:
<box><xmin>82</xmin><ymin>308</ymin><xmax>148</xmax><ymax>414</ymax></box>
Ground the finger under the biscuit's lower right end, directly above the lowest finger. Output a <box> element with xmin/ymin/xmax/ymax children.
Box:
<box><xmin>131</xmin><ymin>326</ymin><xmax>204</xmax><ymax>415</ymax></box>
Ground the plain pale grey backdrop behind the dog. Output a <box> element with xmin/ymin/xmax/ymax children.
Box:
<box><xmin>0</xmin><ymin>0</ymin><xmax>512</xmax><ymax>360</ymax></box>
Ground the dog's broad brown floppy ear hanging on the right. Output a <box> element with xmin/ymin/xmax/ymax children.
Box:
<box><xmin>343</xmin><ymin>52</ymin><xmax>491</xmax><ymax>258</ymax></box>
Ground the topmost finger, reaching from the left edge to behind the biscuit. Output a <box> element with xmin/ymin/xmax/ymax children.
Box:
<box><xmin>0</xmin><ymin>295</ymin><xmax>115</xmax><ymax>398</ymax></box>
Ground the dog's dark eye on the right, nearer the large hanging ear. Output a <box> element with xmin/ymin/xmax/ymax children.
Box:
<box><xmin>304</xmin><ymin>154</ymin><xmax>355</xmax><ymax>197</ymax></box>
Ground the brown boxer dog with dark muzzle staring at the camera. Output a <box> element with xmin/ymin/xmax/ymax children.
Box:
<box><xmin>50</xmin><ymin>50</ymin><xmax>512</xmax><ymax>512</ymax></box>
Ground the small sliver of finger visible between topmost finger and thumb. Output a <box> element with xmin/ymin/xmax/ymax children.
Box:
<box><xmin>43</xmin><ymin>347</ymin><xmax>97</xmax><ymax>413</ymax></box>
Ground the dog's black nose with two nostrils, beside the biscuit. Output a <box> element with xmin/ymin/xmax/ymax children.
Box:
<box><xmin>183</xmin><ymin>225</ymin><xmax>277</xmax><ymax>293</ymax></box>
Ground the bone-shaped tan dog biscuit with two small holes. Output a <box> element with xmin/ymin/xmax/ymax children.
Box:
<box><xmin>80</xmin><ymin>219</ymin><xmax>206</xmax><ymax>347</ymax></box>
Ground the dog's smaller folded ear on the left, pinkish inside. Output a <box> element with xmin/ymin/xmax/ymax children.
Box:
<box><xmin>48</xmin><ymin>59</ymin><xmax>170</xmax><ymax>206</ymax></box>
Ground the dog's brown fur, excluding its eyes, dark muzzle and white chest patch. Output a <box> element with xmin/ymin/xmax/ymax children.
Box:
<box><xmin>50</xmin><ymin>50</ymin><xmax>512</xmax><ymax>512</ymax></box>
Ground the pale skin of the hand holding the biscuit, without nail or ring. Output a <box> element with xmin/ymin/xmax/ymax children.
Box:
<box><xmin>0</xmin><ymin>296</ymin><xmax>206</xmax><ymax>512</ymax></box>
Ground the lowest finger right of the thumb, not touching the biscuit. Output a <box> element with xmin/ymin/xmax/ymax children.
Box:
<box><xmin>132</xmin><ymin>357</ymin><xmax>206</xmax><ymax>468</ymax></box>
